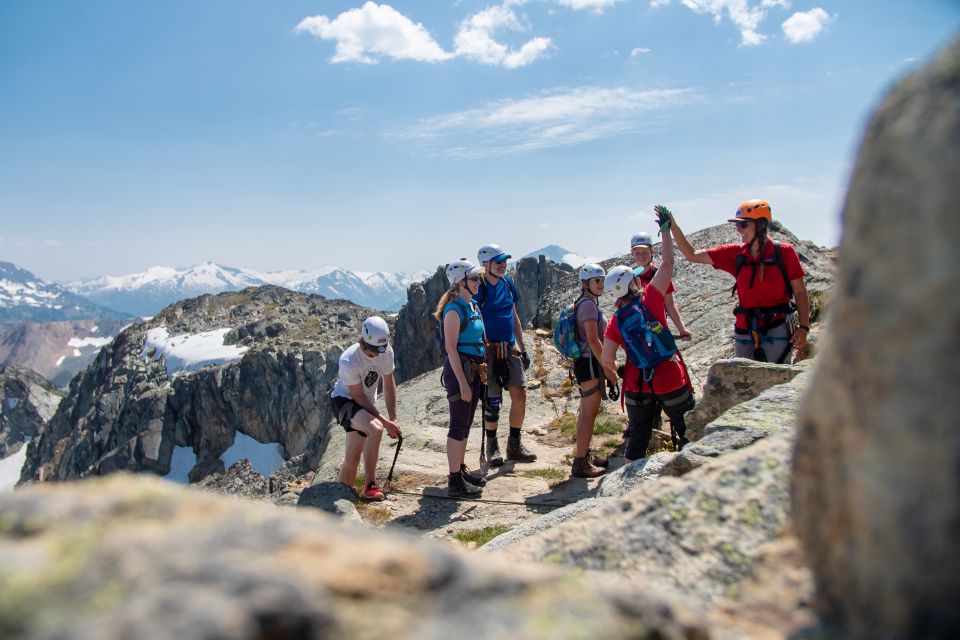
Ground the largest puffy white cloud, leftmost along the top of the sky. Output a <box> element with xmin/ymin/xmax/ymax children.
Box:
<box><xmin>295</xmin><ymin>2</ymin><xmax>453</xmax><ymax>64</ymax></box>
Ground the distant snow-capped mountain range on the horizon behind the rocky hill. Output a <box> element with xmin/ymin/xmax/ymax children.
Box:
<box><xmin>66</xmin><ymin>262</ymin><xmax>428</xmax><ymax>316</ymax></box>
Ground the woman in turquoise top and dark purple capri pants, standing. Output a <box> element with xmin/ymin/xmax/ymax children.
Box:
<box><xmin>436</xmin><ymin>258</ymin><xmax>487</xmax><ymax>498</ymax></box>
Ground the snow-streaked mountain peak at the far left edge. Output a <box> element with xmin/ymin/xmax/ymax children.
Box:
<box><xmin>0</xmin><ymin>262</ymin><xmax>127</xmax><ymax>325</ymax></box>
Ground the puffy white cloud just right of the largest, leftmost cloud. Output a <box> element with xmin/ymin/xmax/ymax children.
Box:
<box><xmin>454</xmin><ymin>5</ymin><xmax>551</xmax><ymax>69</ymax></box>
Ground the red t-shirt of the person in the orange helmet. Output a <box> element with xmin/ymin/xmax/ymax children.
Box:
<box><xmin>707</xmin><ymin>242</ymin><xmax>803</xmax><ymax>329</ymax></box>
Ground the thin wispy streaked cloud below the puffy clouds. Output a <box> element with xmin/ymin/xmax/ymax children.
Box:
<box><xmin>398</xmin><ymin>87</ymin><xmax>694</xmax><ymax>158</ymax></box>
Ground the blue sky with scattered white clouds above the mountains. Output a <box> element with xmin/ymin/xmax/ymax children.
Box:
<box><xmin>0</xmin><ymin>0</ymin><xmax>960</xmax><ymax>281</ymax></box>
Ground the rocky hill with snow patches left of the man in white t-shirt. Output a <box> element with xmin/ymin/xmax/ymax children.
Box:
<box><xmin>23</xmin><ymin>286</ymin><xmax>369</xmax><ymax>480</ymax></box>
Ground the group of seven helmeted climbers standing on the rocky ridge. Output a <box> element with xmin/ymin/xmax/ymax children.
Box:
<box><xmin>333</xmin><ymin>200</ymin><xmax>810</xmax><ymax>500</ymax></box>
